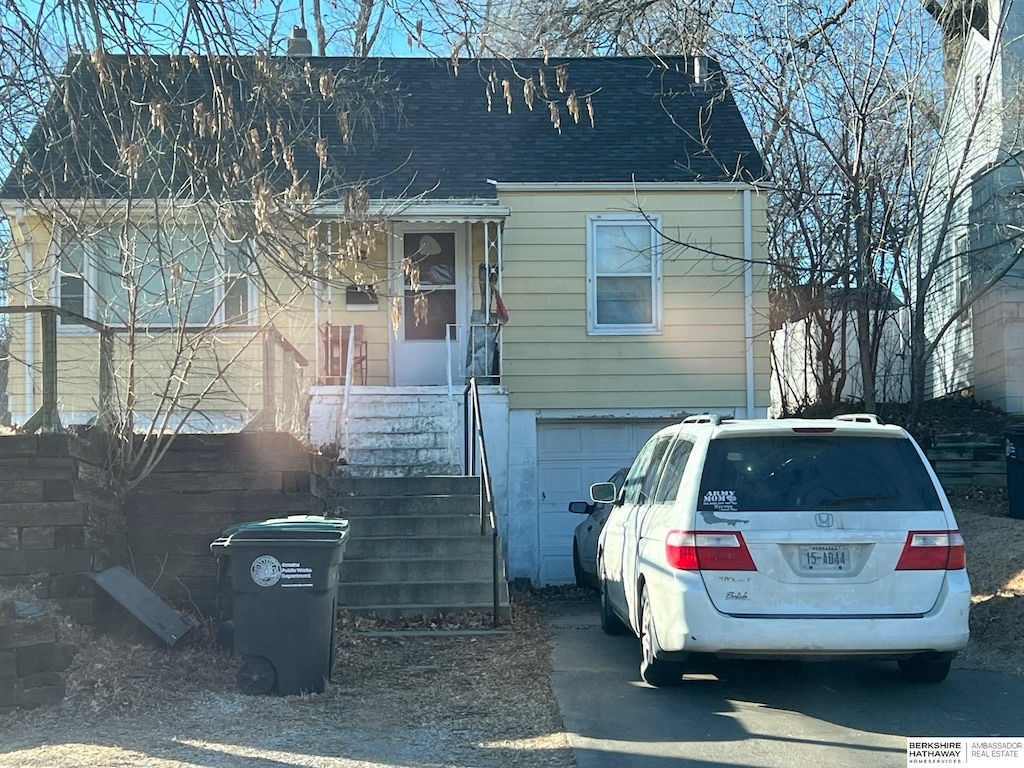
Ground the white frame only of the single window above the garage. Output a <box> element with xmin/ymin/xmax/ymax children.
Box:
<box><xmin>587</xmin><ymin>213</ymin><xmax>663</xmax><ymax>336</ymax></box>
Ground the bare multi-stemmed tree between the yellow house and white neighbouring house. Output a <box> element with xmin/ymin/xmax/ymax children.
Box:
<box><xmin>722</xmin><ymin>2</ymin><xmax>941</xmax><ymax>410</ymax></box>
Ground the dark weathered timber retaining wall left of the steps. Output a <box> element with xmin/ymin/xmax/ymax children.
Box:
<box><xmin>0</xmin><ymin>432</ymin><xmax>332</xmax><ymax>715</ymax></box>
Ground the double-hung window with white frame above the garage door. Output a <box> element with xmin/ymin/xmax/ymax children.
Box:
<box><xmin>587</xmin><ymin>214</ymin><xmax>662</xmax><ymax>334</ymax></box>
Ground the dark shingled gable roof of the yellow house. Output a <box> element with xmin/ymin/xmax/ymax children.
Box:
<box><xmin>0</xmin><ymin>56</ymin><xmax>764</xmax><ymax>200</ymax></box>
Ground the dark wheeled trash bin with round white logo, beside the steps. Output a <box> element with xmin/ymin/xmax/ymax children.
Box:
<box><xmin>210</xmin><ymin>515</ymin><xmax>348</xmax><ymax>696</ymax></box>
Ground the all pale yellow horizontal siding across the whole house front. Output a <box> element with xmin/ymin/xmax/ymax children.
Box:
<box><xmin>2</xmin><ymin>191</ymin><xmax>769</xmax><ymax>423</ymax></box>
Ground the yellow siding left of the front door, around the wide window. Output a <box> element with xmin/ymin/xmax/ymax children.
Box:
<box><xmin>8</xmin><ymin>218</ymin><xmax>399</xmax><ymax>421</ymax></box>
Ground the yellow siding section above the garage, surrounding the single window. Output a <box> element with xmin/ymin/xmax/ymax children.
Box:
<box><xmin>501</xmin><ymin>191</ymin><xmax>769</xmax><ymax>411</ymax></box>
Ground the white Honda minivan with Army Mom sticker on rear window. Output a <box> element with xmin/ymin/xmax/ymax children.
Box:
<box><xmin>591</xmin><ymin>415</ymin><xmax>971</xmax><ymax>686</ymax></box>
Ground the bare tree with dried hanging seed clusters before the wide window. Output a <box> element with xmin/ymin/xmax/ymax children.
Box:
<box><xmin>0</xmin><ymin>0</ymin><xmax>411</xmax><ymax>487</ymax></box>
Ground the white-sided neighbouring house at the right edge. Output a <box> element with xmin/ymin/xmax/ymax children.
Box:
<box><xmin>911</xmin><ymin>0</ymin><xmax>1024</xmax><ymax>413</ymax></box>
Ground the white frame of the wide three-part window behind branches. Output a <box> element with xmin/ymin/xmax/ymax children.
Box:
<box><xmin>50</xmin><ymin>222</ymin><xmax>259</xmax><ymax>334</ymax></box>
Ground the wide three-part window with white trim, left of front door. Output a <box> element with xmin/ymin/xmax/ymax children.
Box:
<box><xmin>54</xmin><ymin>223</ymin><xmax>255</xmax><ymax>328</ymax></box>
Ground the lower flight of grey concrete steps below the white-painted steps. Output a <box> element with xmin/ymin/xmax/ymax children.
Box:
<box><xmin>327</xmin><ymin>475</ymin><xmax>509</xmax><ymax>620</ymax></box>
